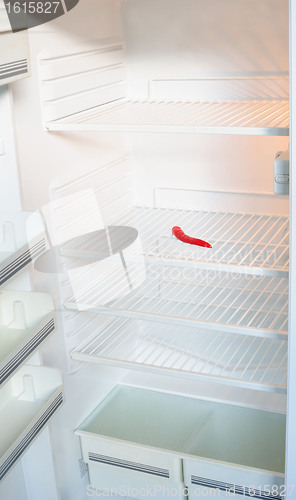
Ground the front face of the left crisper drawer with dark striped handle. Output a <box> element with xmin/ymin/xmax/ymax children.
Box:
<box><xmin>76</xmin><ymin>430</ymin><xmax>183</xmax><ymax>496</ymax></box>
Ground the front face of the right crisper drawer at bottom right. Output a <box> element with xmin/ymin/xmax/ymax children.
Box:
<box><xmin>184</xmin><ymin>458</ymin><xmax>285</xmax><ymax>500</ymax></box>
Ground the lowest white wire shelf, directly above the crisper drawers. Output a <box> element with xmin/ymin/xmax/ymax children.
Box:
<box><xmin>71</xmin><ymin>318</ymin><xmax>287</xmax><ymax>393</ymax></box>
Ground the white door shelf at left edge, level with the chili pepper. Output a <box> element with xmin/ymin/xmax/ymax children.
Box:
<box><xmin>0</xmin><ymin>212</ymin><xmax>46</xmax><ymax>287</ymax></box>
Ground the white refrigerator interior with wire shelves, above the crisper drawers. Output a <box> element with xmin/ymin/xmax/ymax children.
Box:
<box><xmin>0</xmin><ymin>0</ymin><xmax>289</xmax><ymax>500</ymax></box>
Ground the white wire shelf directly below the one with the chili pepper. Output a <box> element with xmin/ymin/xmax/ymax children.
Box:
<box><xmin>65</xmin><ymin>264</ymin><xmax>288</xmax><ymax>338</ymax></box>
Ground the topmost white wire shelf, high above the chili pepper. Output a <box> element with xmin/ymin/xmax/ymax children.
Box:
<box><xmin>46</xmin><ymin>99</ymin><xmax>289</xmax><ymax>135</ymax></box>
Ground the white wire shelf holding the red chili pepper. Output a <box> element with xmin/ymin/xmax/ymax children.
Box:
<box><xmin>113</xmin><ymin>207</ymin><xmax>289</xmax><ymax>277</ymax></box>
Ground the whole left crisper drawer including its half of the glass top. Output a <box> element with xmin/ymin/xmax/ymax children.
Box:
<box><xmin>75</xmin><ymin>386</ymin><xmax>198</xmax><ymax>497</ymax></box>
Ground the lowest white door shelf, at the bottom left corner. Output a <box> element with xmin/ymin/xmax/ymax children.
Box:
<box><xmin>0</xmin><ymin>366</ymin><xmax>64</xmax><ymax>480</ymax></box>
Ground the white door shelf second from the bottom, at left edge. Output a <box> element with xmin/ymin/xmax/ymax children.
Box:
<box><xmin>0</xmin><ymin>290</ymin><xmax>56</xmax><ymax>385</ymax></box>
